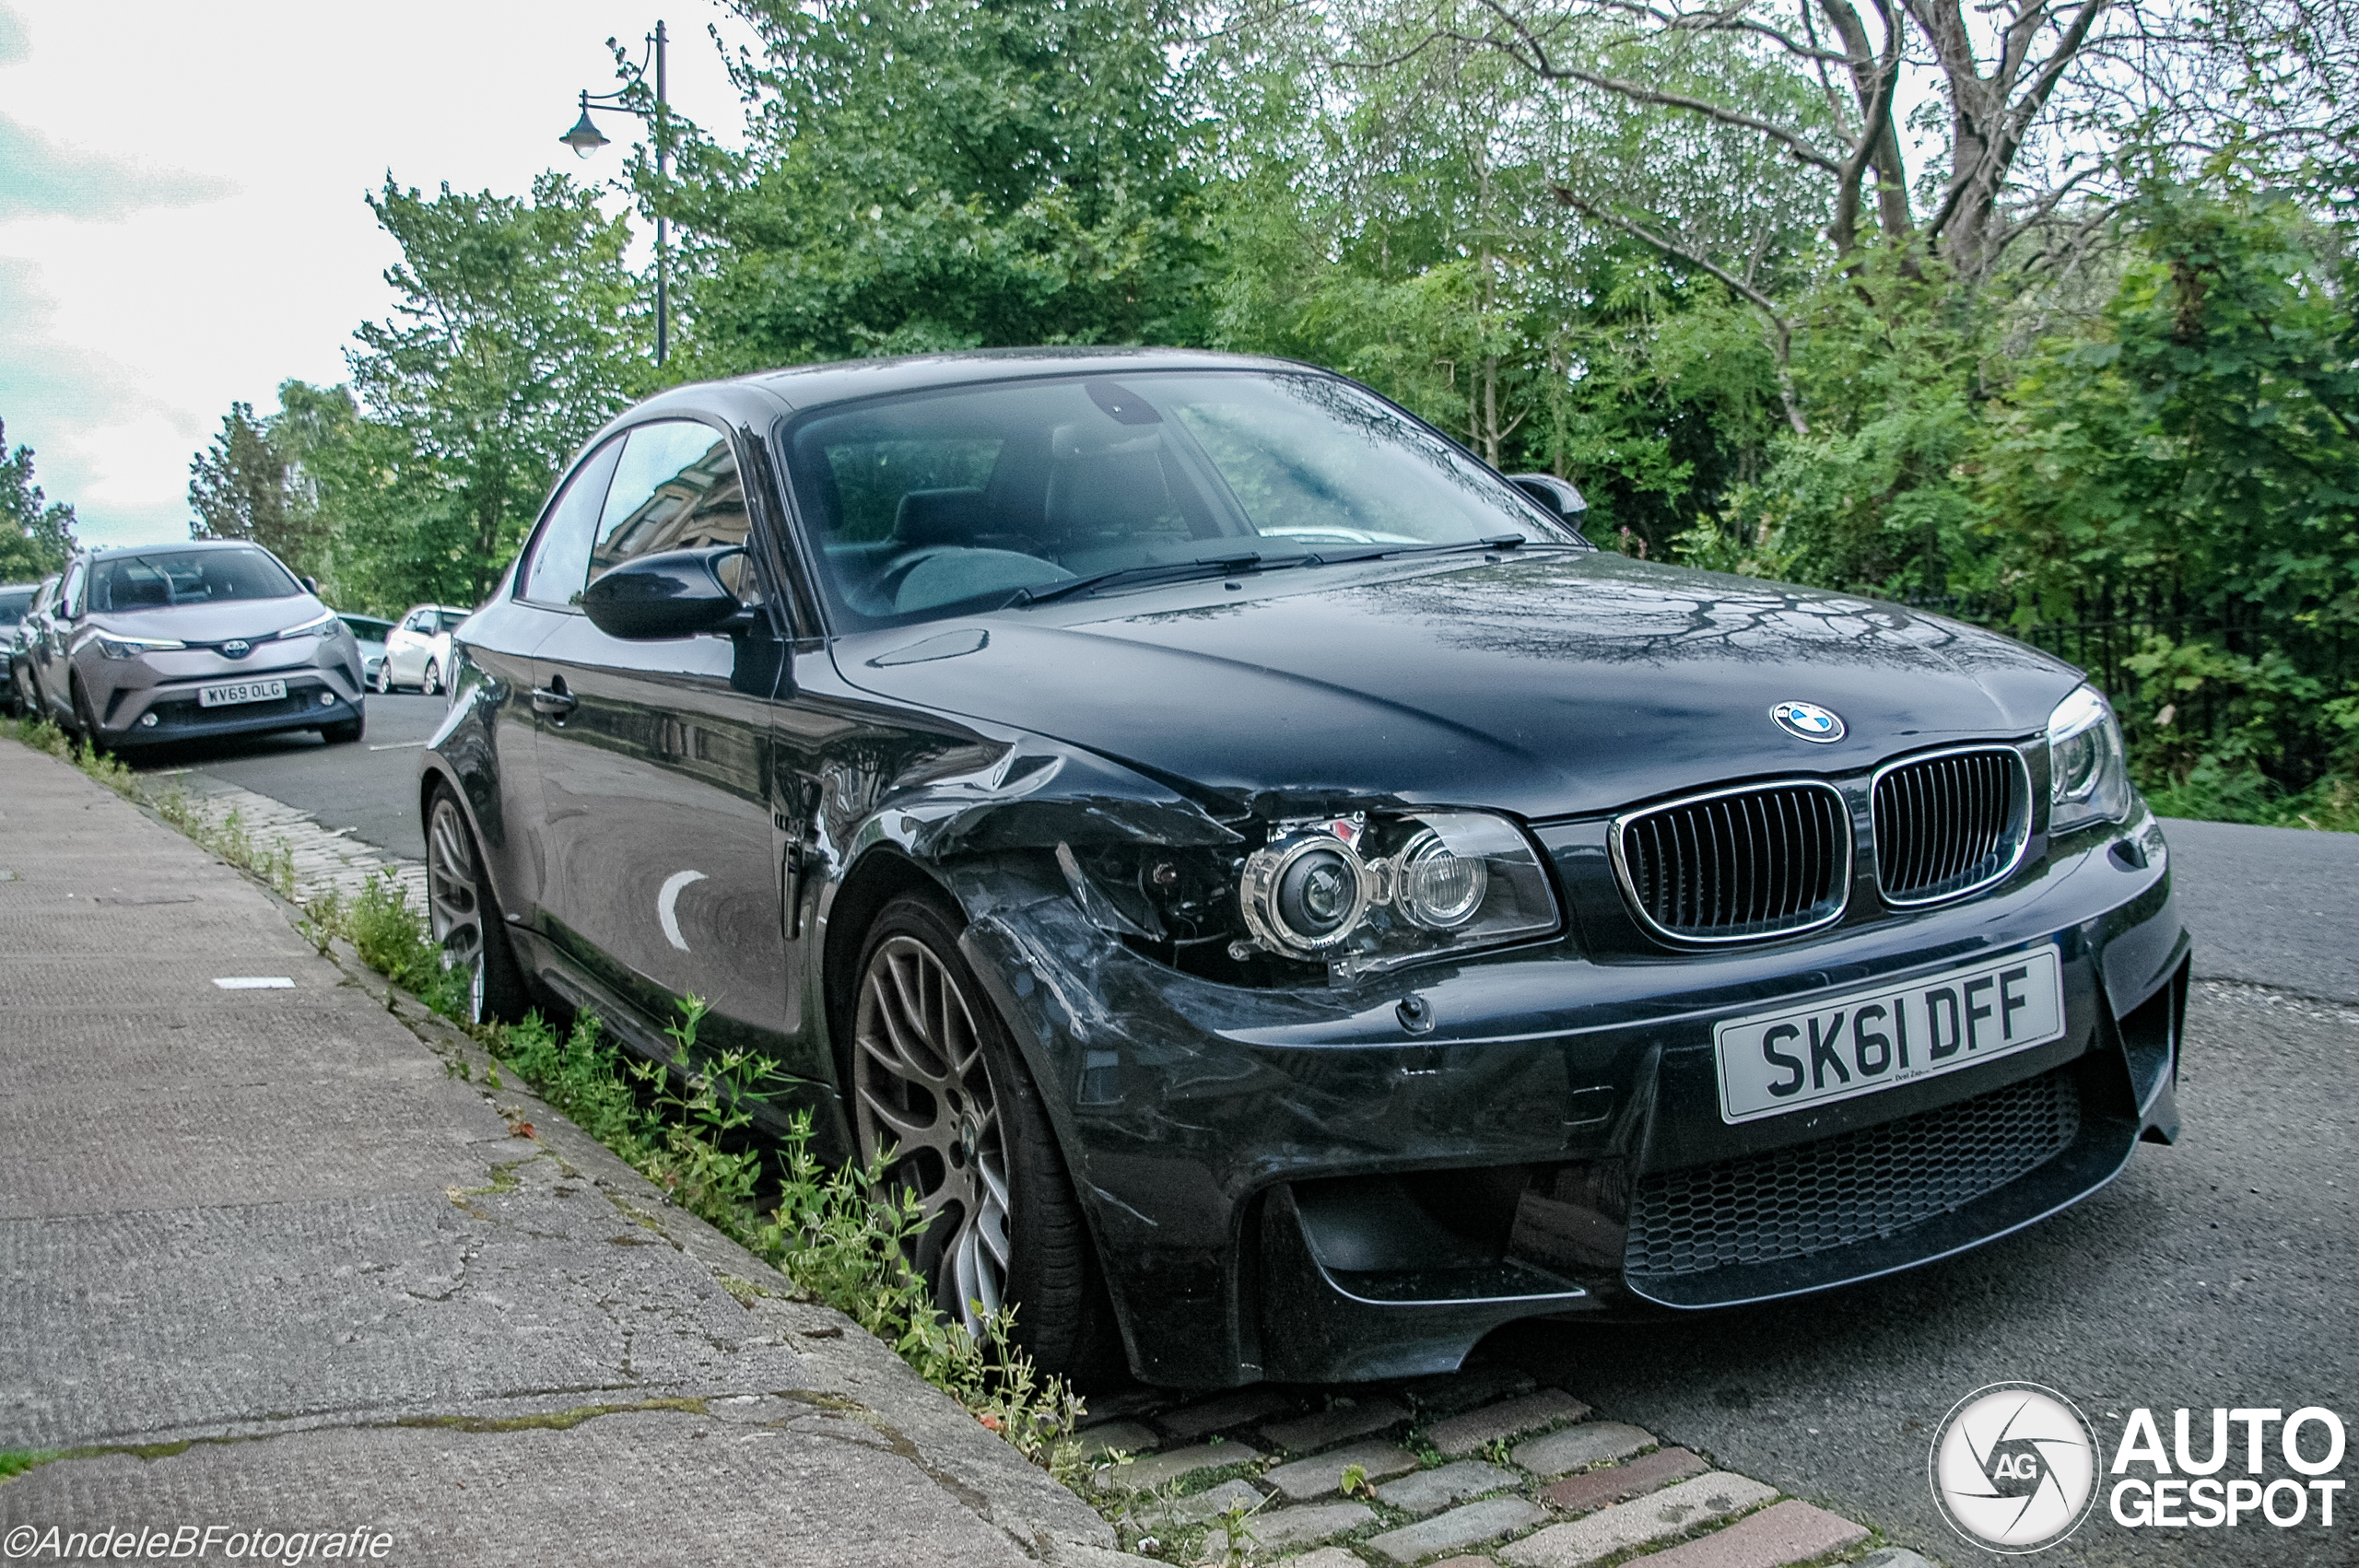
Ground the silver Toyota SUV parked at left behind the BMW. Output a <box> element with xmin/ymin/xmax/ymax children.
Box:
<box><xmin>41</xmin><ymin>540</ymin><xmax>366</xmax><ymax>747</ymax></box>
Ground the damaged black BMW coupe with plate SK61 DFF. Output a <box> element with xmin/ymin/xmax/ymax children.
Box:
<box><xmin>420</xmin><ymin>351</ymin><xmax>2189</xmax><ymax>1387</ymax></box>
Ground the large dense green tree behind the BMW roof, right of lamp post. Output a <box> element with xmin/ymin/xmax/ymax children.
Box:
<box><xmin>670</xmin><ymin>0</ymin><xmax>1205</xmax><ymax>372</ymax></box>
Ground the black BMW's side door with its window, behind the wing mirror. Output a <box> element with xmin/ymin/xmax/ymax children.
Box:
<box><xmin>534</xmin><ymin>420</ymin><xmax>788</xmax><ymax>1057</ymax></box>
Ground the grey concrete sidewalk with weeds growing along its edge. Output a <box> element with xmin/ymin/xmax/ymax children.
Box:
<box><xmin>0</xmin><ymin>743</ymin><xmax>1137</xmax><ymax>1568</ymax></box>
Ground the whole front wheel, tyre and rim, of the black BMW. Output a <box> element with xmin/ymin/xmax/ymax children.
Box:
<box><xmin>851</xmin><ymin>896</ymin><xmax>1113</xmax><ymax>1375</ymax></box>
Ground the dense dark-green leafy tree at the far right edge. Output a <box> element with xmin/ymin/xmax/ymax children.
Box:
<box><xmin>1979</xmin><ymin>181</ymin><xmax>2359</xmax><ymax>788</ymax></box>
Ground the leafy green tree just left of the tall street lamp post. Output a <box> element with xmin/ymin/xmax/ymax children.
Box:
<box><xmin>337</xmin><ymin>174</ymin><xmax>646</xmax><ymax>603</ymax></box>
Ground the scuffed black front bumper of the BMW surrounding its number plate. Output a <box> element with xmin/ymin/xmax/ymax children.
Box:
<box><xmin>953</xmin><ymin>816</ymin><xmax>2187</xmax><ymax>1387</ymax></box>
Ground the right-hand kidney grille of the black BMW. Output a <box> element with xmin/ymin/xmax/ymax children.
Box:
<box><xmin>1875</xmin><ymin>745</ymin><xmax>2031</xmax><ymax>903</ymax></box>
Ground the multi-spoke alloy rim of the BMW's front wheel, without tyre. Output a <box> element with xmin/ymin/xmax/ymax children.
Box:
<box><xmin>851</xmin><ymin>934</ymin><xmax>1012</xmax><ymax>1337</ymax></box>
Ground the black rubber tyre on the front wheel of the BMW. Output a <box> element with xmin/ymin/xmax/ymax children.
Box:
<box><xmin>844</xmin><ymin>894</ymin><xmax>1121</xmax><ymax>1379</ymax></box>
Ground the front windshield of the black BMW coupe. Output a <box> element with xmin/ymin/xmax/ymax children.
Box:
<box><xmin>788</xmin><ymin>368</ymin><xmax>1571</xmax><ymax>627</ymax></box>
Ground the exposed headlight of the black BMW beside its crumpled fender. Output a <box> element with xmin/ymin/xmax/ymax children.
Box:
<box><xmin>1236</xmin><ymin>811</ymin><xmax>1557</xmax><ymax>978</ymax></box>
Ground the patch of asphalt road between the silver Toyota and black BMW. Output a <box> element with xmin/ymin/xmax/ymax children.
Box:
<box><xmin>132</xmin><ymin>691</ymin><xmax>451</xmax><ymax>860</ymax></box>
